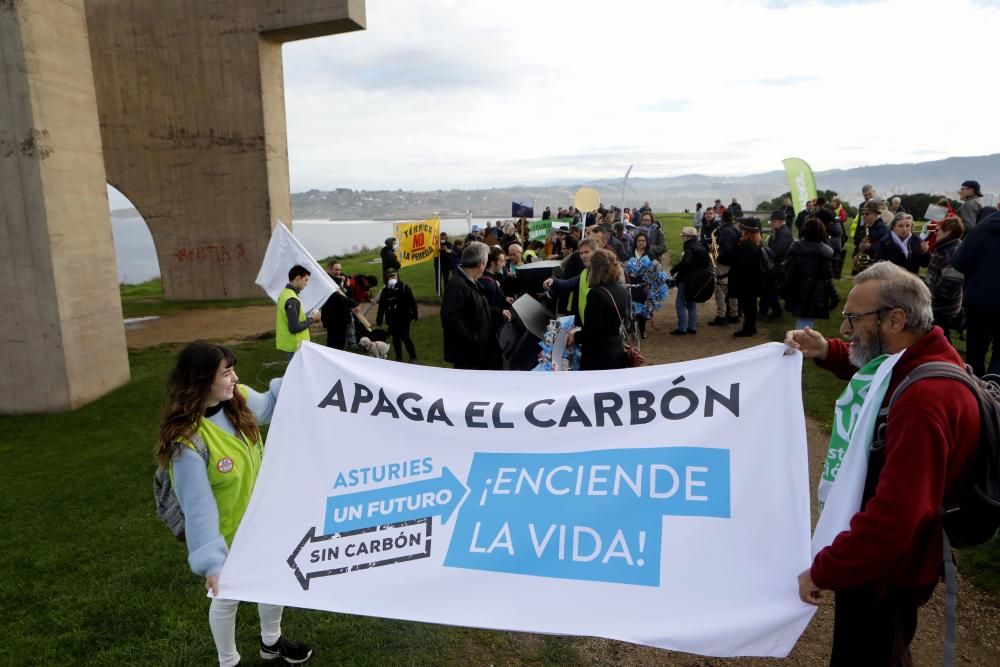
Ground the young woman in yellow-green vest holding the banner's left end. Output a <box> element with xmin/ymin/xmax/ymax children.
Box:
<box><xmin>155</xmin><ymin>342</ymin><xmax>312</xmax><ymax>667</ymax></box>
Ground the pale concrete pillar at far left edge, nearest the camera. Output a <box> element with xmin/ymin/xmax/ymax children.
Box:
<box><xmin>0</xmin><ymin>0</ymin><xmax>129</xmax><ymax>414</ymax></box>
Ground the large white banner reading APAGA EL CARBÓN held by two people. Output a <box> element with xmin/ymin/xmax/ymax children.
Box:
<box><xmin>220</xmin><ymin>343</ymin><xmax>814</xmax><ymax>656</ymax></box>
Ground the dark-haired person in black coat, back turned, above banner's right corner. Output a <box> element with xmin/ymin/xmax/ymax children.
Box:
<box><xmin>780</xmin><ymin>218</ymin><xmax>836</xmax><ymax>329</ymax></box>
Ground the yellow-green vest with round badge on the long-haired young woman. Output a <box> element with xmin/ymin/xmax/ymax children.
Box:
<box><xmin>170</xmin><ymin>385</ymin><xmax>264</xmax><ymax>546</ymax></box>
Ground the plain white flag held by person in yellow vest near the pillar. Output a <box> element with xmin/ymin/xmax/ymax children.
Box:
<box><xmin>254</xmin><ymin>220</ymin><xmax>338</xmax><ymax>314</ymax></box>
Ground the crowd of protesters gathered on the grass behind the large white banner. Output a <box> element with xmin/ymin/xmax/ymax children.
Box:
<box><xmin>308</xmin><ymin>181</ymin><xmax>1000</xmax><ymax>380</ymax></box>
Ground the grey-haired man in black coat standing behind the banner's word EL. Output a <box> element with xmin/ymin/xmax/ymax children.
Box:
<box><xmin>441</xmin><ymin>241</ymin><xmax>510</xmax><ymax>370</ymax></box>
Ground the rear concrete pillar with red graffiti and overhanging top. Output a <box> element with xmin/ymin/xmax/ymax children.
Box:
<box><xmin>86</xmin><ymin>0</ymin><xmax>365</xmax><ymax>299</ymax></box>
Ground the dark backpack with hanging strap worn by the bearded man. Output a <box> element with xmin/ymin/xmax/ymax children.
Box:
<box><xmin>889</xmin><ymin>361</ymin><xmax>1000</xmax><ymax>667</ymax></box>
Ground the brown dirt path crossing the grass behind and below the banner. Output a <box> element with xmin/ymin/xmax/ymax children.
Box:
<box><xmin>126</xmin><ymin>303</ymin><xmax>1000</xmax><ymax>667</ymax></box>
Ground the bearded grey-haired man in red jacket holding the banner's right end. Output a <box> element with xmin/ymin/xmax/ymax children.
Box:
<box><xmin>785</xmin><ymin>262</ymin><xmax>979</xmax><ymax>665</ymax></box>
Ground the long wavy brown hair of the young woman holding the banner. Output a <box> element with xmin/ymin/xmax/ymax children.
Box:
<box><xmin>154</xmin><ymin>342</ymin><xmax>260</xmax><ymax>467</ymax></box>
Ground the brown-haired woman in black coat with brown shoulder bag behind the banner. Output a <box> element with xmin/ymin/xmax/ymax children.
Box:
<box><xmin>573</xmin><ymin>249</ymin><xmax>632</xmax><ymax>371</ymax></box>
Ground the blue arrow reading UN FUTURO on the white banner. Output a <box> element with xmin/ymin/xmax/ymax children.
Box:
<box><xmin>323</xmin><ymin>468</ymin><xmax>468</xmax><ymax>535</ymax></box>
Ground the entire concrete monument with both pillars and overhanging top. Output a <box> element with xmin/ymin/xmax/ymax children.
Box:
<box><xmin>0</xmin><ymin>0</ymin><xmax>365</xmax><ymax>414</ymax></box>
